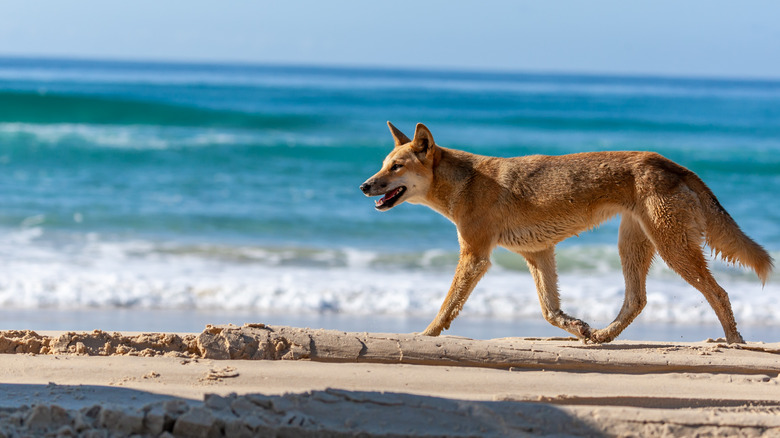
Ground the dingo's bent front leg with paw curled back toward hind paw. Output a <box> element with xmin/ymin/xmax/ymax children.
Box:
<box><xmin>520</xmin><ymin>248</ymin><xmax>590</xmax><ymax>341</ymax></box>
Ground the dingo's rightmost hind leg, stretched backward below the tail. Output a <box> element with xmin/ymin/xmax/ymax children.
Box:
<box><xmin>645</xmin><ymin>198</ymin><xmax>745</xmax><ymax>343</ymax></box>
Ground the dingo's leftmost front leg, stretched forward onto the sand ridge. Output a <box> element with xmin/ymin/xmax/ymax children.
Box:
<box><xmin>422</xmin><ymin>248</ymin><xmax>490</xmax><ymax>336</ymax></box>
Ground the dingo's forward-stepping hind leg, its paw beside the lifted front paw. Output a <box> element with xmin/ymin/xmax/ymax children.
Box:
<box><xmin>590</xmin><ymin>214</ymin><xmax>655</xmax><ymax>343</ymax></box>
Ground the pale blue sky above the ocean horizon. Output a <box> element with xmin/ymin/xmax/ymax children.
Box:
<box><xmin>0</xmin><ymin>0</ymin><xmax>780</xmax><ymax>79</ymax></box>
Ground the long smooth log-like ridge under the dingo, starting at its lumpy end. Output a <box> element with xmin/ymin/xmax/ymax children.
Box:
<box><xmin>190</xmin><ymin>324</ymin><xmax>780</xmax><ymax>374</ymax></box>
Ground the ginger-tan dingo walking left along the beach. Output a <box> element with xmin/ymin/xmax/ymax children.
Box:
<box><xmin>360</xmin><ymin>122</ymin><xmax>773</xmax><ymax>343</ymax></box>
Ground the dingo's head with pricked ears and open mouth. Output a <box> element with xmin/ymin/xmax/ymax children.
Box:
<box><xmin>360</xmin><ymin>122</ymin><xmax>437</xmax><ymax>211</ymax></box>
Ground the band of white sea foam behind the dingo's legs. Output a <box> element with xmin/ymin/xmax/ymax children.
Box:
<box><xmin>0</xmin><ymin>227</ymin><xmax>780</xmax><ymax>326</ymax></box>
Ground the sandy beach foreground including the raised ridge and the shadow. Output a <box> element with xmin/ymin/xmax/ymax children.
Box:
<box><xmin>0</xmin><ymin>324</ymin><xmax>780</xmax><ymax>437</ymax></box>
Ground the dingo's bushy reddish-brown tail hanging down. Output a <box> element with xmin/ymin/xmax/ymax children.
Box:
<box><xmin>685</xmin><ymin>172</ymin><xmax>774</xmax><ymax>284</ymax></box>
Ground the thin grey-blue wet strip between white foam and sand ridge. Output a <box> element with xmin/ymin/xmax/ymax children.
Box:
<box><xmin>0</xmin><ymin>308</ymin><xmax>780</xmax><ymax>343</ymax></box>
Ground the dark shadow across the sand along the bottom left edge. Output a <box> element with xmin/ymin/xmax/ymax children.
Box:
<box><xmin>0</xmin><ymin>384</ymin><xmax>604</xmax><ymax>437</ymax></box>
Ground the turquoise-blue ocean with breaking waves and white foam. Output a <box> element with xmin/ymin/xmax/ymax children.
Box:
<box><xmin>0</xmin><ymin>58</ymin><xmax>780</xmax><ymax>342</ymax></box>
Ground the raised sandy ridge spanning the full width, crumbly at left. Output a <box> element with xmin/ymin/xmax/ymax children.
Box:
<box><xmin>0</xmin><ymin>324</ymin><xmax>780</xmax><ymax>374</ymax></box>
